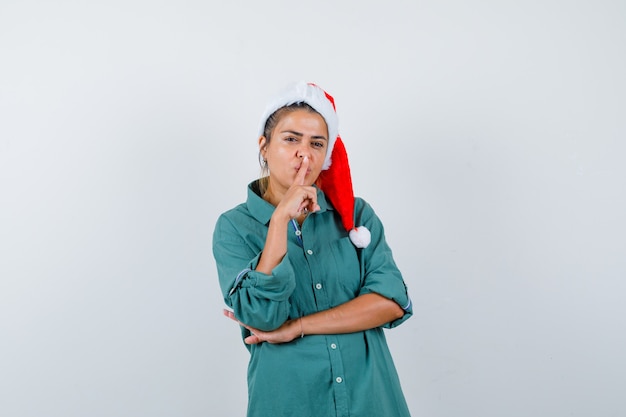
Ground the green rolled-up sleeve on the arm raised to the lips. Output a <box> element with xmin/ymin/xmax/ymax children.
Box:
<box><xmin>213</xmin><ymin>215</ymin><xmax>296</xmax><ymax>331</ymax></box>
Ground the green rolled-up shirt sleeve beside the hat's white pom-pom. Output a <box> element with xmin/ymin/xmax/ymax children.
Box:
<box><xmin>355</xmin><ymin>199</ymin><xmax>413</xmax><ymax>328</ymax></box>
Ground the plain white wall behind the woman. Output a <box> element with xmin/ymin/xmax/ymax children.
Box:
<box><xmin>0</xmin><ymin>0</ymin><xmax>626</xmax><ymax>417</ymax></box>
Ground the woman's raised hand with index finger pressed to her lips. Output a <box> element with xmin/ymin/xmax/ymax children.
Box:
<box><xmin>275</xmin><ymin>156</ymin><xmax>320</xmax><ymax>219</ymax></box>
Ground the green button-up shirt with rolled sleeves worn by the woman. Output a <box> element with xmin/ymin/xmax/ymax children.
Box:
<box><xmin>213</xmin><ymin>181</ymin><xmax>412</xmax><ymax>417</ymax></box>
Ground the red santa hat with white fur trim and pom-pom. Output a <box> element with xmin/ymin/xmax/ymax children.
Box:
<box><xmin>259</xmin><ymin>82</ymin><xmax>371</xmax><ymax>248</ymax></box>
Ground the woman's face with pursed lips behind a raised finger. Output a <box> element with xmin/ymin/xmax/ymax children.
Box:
<box><xmin>259</xmin><ymin>109</ymin><xmax>328</xmax><ymax>197</ymax></box>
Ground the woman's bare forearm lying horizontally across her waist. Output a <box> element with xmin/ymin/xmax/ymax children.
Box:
<box><xmin>300</xmin><ymin>293</ymin><xmax>404</xmax><ymax>335</ymax></box>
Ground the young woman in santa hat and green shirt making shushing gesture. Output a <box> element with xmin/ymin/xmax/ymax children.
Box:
<box><xmin>213</xmin><ymin>83</ymin><xmax>412</xmax><ymax>417</ymax></box>
